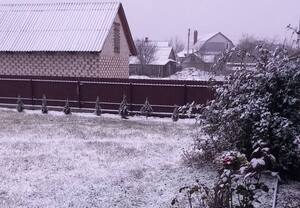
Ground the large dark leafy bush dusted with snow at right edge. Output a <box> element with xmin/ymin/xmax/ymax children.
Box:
<box><xmin>198</xmin><ymin>47</ymin><xmax>300</xmax><ymax>177</ymax></box>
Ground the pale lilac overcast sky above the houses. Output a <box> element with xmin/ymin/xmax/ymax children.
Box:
<box><xmin>0</xmin><ymin>0</ymin><xmax>300</xmax><ymax>42</ymax></box>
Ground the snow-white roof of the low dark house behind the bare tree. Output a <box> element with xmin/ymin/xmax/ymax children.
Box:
<box><xmin>129</xmin><ymin>42</ymin><xmax>176</xmax><ymax>65</ymax></box>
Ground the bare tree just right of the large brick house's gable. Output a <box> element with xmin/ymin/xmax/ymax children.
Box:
<box><xmin>135</xmin><ymin>38</ymin><xmax>157</xmax><ymax>66</ymax></box>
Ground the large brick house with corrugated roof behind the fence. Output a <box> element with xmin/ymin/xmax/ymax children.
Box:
<box><xmin>0</xmin><ymin>2</ymin><xmax>136</xmax><ymax>78</ymax></box>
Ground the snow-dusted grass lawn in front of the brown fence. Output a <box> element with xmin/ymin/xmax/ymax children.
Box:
<box><xmin>0</xmin><ymin>109</ymin><xmax>214</xmax><ymax>208</ymax></box>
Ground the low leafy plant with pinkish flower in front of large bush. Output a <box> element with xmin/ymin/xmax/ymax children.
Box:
<box><xmin>171</xmin><ymin>151</ymin><xmax>269</xmax><ymax>208</ymax></box>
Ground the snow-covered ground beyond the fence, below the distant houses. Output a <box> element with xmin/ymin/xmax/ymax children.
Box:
<box><xmin>130</xmin><ymin>68</ymin><xmax>225</xmax><ymax>81</ymax></box>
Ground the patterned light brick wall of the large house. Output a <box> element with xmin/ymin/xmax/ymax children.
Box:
<box><xmin>0</xmin><ymin>12</ymin><xmax>129</xmax><ymax>78</ymax></box>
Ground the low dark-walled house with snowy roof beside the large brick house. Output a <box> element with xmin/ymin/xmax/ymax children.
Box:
<box><xmin>130</xmin><ymin>41</ymin><xmax>177</xmax><ymax>77</ymax></box>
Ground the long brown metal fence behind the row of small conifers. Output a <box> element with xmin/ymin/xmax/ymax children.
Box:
<box><xmin>0</xmin><ymin>76</ymin><xmax>222</xmax><ymax>113</ymax></box>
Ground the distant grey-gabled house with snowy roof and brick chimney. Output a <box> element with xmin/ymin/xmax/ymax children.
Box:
<box><xmin>177</xmin><ymin>31</ymin><xmax>234</xmax><ymax>69</ymax></box>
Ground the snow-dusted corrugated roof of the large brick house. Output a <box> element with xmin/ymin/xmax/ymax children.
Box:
<box><xmin>0</xmin><ymin>2</ymin><xmax>136</xmax><ymax>54</ymax></box>
